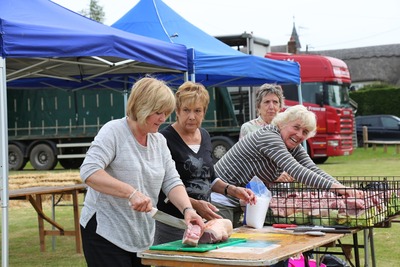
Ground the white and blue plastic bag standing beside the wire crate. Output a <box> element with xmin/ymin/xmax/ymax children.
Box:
<box><xmin>244</xmin><ymin>176</ymin><xmax>272</xmax><ymax>229</ymax></box>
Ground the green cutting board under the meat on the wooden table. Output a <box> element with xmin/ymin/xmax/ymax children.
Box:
<box><xmin>150</xmin><ymin>238</ymin><xmax>246</xmax><ymax>252</ymax></box>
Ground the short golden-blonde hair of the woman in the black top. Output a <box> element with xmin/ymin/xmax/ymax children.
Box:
<box><xmin>175</xmin><ymin>81</ymin><xmax>210</xmax><ymax>113</ymax></box>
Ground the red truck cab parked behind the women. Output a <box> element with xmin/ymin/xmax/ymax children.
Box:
<box><xmin>265</xmin><ymin>53</ymin><xmax>354</xmax><ymax>163</ymax></box>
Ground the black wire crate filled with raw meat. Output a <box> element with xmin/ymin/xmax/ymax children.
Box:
<box><xmin>266</xmin><ymin>176</ymin><xmax>400</xmax><ymax>227</ymax></box>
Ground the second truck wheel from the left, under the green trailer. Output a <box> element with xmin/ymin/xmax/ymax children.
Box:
<box><xmin>29</xmin><ymin>144</ymin><xmax>57</xmax><ymax>170</ymax></box>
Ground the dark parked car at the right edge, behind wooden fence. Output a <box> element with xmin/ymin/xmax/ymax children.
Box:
<box><xmin>356</xmin><ymin>115</ymin><xmax>400</xmax><ymax>147</ymax></box>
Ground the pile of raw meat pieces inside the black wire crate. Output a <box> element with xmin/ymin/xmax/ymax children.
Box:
<box><xmin>268</xmin><ymin>189</ymin><xmax>395</xmax><ymax>227</ymax></box>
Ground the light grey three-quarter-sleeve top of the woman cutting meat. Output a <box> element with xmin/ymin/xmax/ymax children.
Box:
<box><xmin>80</xmin><ymin>118</ymin><xmax>183</xmax><ymax>252</ymax></box>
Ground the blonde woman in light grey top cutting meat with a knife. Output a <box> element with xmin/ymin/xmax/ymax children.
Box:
<box><xmin>80</xmin><ymin>77</ymin><xmax>204</xmax><ymax>266</ymax></box>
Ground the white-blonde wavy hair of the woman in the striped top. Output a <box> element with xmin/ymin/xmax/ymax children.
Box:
<box><xmin>271</xmin><ymin>105</ymin><xmax>317</xmax><ymax>139</ymax></box>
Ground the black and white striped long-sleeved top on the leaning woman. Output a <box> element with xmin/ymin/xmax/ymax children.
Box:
<box><xmin>214</xmin><ymin>125</ymin><xmax>337</xmax><ymax>194</ymax></box>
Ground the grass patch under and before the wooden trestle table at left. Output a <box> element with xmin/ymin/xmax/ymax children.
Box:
<box><xmin>5</xmin><ymin>201</ymin><xmax>86</xmax><ymax>267</ymax></box>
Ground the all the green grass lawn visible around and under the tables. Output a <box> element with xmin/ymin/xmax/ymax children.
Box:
<box><xmin>3</xmin><ymin>147</ymin><xmax>400</xmax><ymax>267</ymax></box>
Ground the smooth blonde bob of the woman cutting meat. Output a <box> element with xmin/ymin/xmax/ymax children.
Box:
<box><xmin>126</xmin><ymin>77</ymin><xmax>175</xmax><ymax>125</ymax></box>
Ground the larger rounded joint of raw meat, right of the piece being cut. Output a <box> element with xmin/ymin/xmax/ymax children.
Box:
<box><xmin>199</xmin><ymin>219</ymin><xmax>233</xmax><ymax>244</ymax></box>
